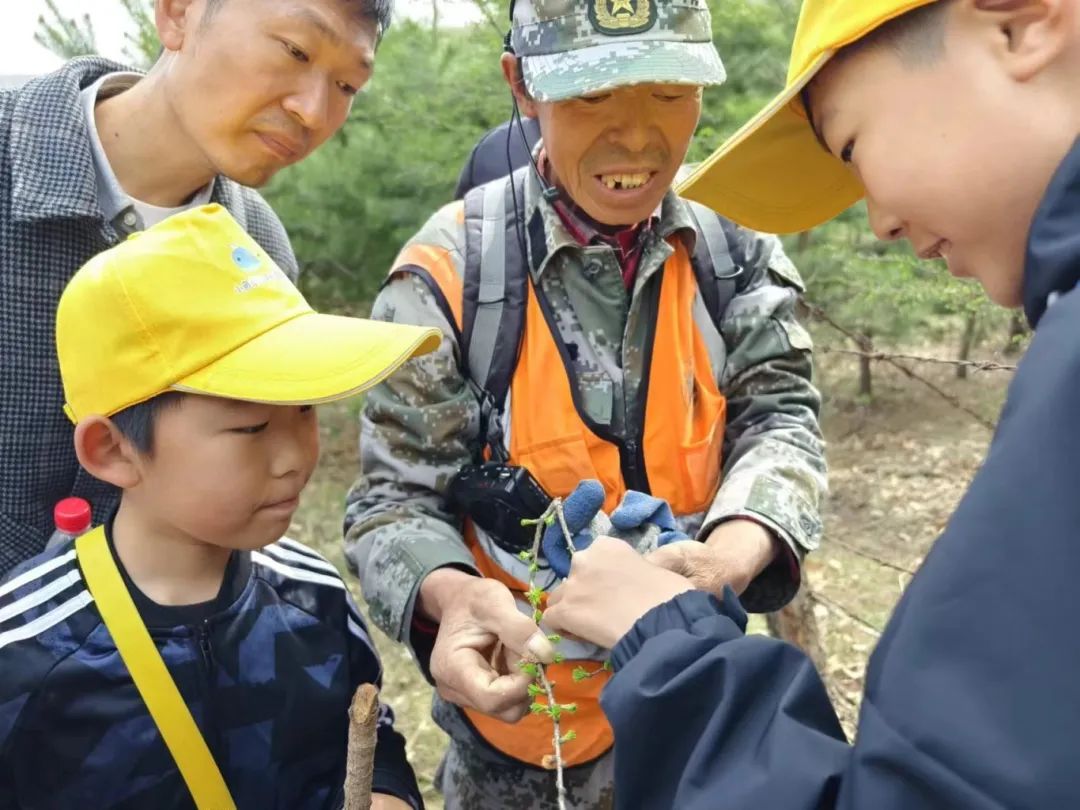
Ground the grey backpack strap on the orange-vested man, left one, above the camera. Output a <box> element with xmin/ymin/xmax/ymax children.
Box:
<box><xmin>461</xmin><ymin>172</ymin><xmax>529</xmax><ymax>461</ymax></box>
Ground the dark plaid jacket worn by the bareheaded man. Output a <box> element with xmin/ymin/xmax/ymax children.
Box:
<box><xmin>0</xmin><ymin>57</ymin><xmax>297</xmax><ymax>576</ymax></box>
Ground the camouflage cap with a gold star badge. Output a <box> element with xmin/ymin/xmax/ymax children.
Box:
<box><xmin>510</xmin><ymin>0</ymin><xmax>727</xmax><ymax>102</ymax></box>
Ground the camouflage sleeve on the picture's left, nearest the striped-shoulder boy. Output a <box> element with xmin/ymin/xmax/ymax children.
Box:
<box><xmin>345</xmin><ymin>274</ymin><xmax>480</xmax><ymax>667</ymax></box>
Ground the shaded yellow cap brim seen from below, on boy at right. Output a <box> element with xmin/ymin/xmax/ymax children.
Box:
<box><xmin>676</xmin><ymin>53</ymin><xmax>864</xmax><ymax>233</ymax></box>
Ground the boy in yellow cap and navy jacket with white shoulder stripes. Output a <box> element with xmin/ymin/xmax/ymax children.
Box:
<box><xmin>0</xmin><ymin>205</ymin><xmax>440</xmax><ymax>810</ymax></box>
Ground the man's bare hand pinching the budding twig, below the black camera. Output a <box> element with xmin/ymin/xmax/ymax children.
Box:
<box><xmin>420</xmin><ymin>568</ymin><xmax>555</xmax><ymax>723</ymax></box>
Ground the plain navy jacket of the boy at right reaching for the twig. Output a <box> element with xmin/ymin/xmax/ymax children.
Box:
<box><xmin>602</xmin><ymin>141</ymin><xmax>1080</xmax><ymax>810</ymax></box>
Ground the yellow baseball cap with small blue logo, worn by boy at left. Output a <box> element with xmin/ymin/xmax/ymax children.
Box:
<box><xmin>56</xmin><ymin>205</ymin><xmax>441</xmax><ymax>421</ymax></box>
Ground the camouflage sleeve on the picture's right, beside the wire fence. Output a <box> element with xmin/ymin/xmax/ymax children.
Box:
<box><xmin>701</xmin><ymin>229</ymin><xmax>826</xmax><ymax>612</ymax></box>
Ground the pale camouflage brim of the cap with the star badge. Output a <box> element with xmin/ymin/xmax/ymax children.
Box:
<box><xmin>522</xmin><ymin>40</ymin><xmax>727</xmax><ymax>102</ymax></box>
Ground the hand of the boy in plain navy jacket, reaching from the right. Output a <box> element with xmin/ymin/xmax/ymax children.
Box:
<box><xmin>543</xmin><ymin>537</ymin><xmax>693</xmax><ymax>648</ymax></box>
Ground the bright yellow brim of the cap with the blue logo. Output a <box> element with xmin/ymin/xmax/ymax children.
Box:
<box><xmin>173</xmin><ymin>312</ymin><xmax>442</xmax><ymax>405</ymax></box>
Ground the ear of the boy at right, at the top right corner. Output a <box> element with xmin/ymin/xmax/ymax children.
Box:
<box><xmin>973</xmin><ymin>0</ymin><xmax>1077</xmax><ymax>81</ymax></box>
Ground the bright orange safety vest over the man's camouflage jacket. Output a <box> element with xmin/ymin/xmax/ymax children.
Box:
<box><xmin>391</xmin><ymin>189</ymin><xmax>726</xmax><ymax>767</ymax></box>
